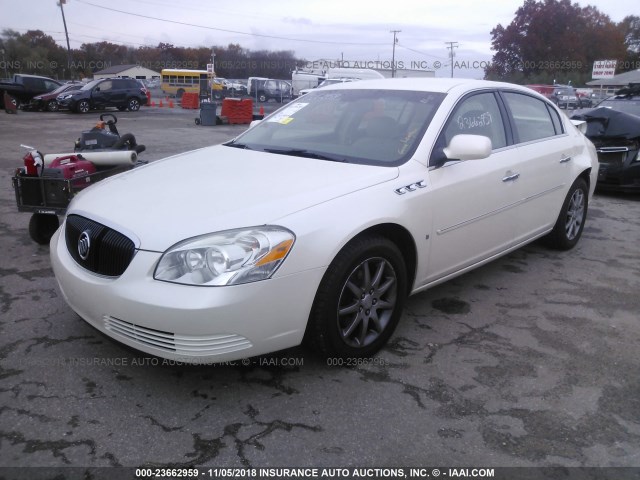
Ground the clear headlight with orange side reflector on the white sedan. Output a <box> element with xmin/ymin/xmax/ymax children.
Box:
<box><xmin>153</xmin><ymin>226</ymin><xmax>295</xmax><ymax>286</ymax></box>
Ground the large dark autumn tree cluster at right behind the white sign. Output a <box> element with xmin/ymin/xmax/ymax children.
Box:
<box><xmin>485</xmin><ymin>0</ymin><xmax>640</xmax><ymax>85</ymax></box>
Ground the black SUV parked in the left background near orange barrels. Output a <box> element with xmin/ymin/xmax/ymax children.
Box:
<box><xmin>56</xmin><ymin>78</ymin><xmax>147</xmax><ymax>113</ymax></box>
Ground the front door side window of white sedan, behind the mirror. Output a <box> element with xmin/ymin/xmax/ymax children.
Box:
<box><xmin>439</xmin><ymin>92</ymin><xmax>507</xmax><ymax>150</ymax></box>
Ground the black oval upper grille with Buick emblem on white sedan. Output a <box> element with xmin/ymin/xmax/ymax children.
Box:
<box><xmin>65</xmin><ymin>215</ymin><xmax>136</xmax><ymax>277</ymax></box>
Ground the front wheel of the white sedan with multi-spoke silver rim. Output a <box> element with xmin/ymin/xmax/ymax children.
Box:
<box><xmin>305</xmin><ymin>235</ymin><xmax>407</xmax><ymax>358</ymax></box>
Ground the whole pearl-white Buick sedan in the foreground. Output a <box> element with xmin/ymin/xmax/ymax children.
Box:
<box><xmin>51</xmin><ymin>79</ymin><xmax>598</xmax><ymax>363</ymax></box>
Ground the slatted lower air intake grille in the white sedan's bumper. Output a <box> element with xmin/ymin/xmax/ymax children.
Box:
<box><xmin>103</xmin><ymin>316</ymin><xmax>252</xmax><ymax>357</ymax></box>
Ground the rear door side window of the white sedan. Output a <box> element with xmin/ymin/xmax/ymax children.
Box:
<box><xmin>503</xmin><ymin>92</ymin><xmax>562</xmax><ymax>143</ymax></box>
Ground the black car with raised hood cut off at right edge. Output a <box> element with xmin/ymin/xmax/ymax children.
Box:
<box><xmin>572</xmin><ymin>84</ymin><xmax>640</xmax><ymax>191</ymax></box>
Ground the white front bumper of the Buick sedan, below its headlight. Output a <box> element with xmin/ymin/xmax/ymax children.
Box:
<box><xmin>51</xmin><ymin>224</ymin><xmax>324</xmax><ymax>363</ymax></box>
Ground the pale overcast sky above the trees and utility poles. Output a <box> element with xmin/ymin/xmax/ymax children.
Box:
<box><xmin>0</xmin><ymin>0</ymin><xmax>638</xmax><ymax>78</ymax></box>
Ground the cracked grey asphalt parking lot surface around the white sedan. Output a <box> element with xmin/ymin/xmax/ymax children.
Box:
<box><xmin>0</xmin><ymin>104</ymin><xmax>640</xmax><ymax>478</ymax></box>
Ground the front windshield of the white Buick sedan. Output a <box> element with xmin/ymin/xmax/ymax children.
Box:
<box><xmin>227</xmin><ymin>89</ymin><xmax>445</xmax><ymax>166</ymax></box>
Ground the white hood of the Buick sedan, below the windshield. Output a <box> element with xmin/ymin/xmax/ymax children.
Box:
<box><xmin>69</xmin><ymin>145</ymin><xmax>398</xmax><ymax>251</ymax></box>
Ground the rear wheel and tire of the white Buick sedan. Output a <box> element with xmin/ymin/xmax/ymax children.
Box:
<box><xmin>544</xmin><ymin>178</ymin><xmax>589</xmax><ymax>250</ymax></box>
